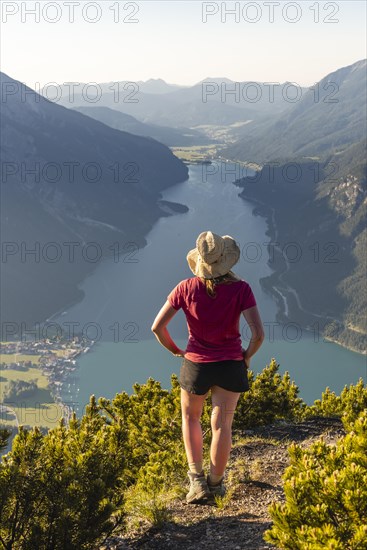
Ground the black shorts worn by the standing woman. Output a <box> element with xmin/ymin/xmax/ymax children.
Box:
<box><xmin>180</xmin><ymin>357</ymin><xmax>249</xmax><ymax>395</ymax></box>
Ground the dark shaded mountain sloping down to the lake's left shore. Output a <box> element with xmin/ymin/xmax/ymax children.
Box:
<box><xmin>0</xmin><ymin>74</ymin><xmax>188</xmax><ymax>332</ymax></box>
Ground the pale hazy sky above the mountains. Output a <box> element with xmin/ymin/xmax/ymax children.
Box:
<box><xmin>0</xmin><ymin>0</ymin><xmax>366</xmax><ymax>88</ymax></box>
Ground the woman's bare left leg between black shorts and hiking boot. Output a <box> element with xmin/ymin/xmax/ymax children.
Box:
<box><xmin>181</xmin><ymin>388</ymin><xmax>208</xmax><ymax>463</ymax></box>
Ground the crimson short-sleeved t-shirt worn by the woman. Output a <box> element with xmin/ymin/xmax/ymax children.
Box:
<box><xmin>167</xmin><ymin>277</ymin><xmax>256</xmax><ymax>363</ymax></box>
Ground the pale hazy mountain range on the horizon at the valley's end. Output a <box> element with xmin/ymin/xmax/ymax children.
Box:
<box><xmin>51</xmin><ymin>77</ymin><xmax>306</xmax><ymax>128</ymax></box>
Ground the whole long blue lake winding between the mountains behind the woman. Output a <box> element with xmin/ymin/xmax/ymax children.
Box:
<box><xmin>47</xmin><ymin>164</ymin><xmax>367</xmax><ymax>412</ymax></box>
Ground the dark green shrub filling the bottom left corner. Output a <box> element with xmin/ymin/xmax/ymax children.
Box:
<box><xmin>0</xmin><ymin>398</ymin><xmax>124</xmax><ymax>550</ymax></box>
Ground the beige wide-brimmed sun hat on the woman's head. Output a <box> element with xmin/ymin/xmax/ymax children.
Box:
<box><xmin>186</xmin><ymin>231</ymin><xmax>240</xmax><ymax>279</ymax></box>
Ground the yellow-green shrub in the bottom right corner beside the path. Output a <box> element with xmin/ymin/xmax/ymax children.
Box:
<box><xmin>264</xmin><ymin>409</ymin><xmax>367</xmax><ymax>550</ymax></box>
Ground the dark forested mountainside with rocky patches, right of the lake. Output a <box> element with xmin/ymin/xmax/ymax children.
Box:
<box><xmin>235</xmin><ymin>140</ymin><xmax>367</xmax><ymax>353</ymax></box>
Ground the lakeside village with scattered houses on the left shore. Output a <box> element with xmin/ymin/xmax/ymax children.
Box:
<box><xmin>0</xmin><ymin>335</ymin><xmax>95</xmax><ymax>421</ymax></box>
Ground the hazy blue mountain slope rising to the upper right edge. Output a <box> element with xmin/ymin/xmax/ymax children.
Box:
<box><xmin>226</xmin><ymin>59</ymin><xmax>367</xmax><ymax>164</ymax></box>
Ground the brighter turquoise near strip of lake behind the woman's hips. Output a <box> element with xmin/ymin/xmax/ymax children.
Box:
<box><xmin>73</xmin><ymin>336</ymin><xmax>366</xmax><ymax>411</ymax></box>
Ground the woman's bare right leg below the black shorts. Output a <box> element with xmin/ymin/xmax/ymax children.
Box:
<box><xmin>210</xmin><ymin>386</ymin><xmax>240</xmax><ymax>476</ymax></box>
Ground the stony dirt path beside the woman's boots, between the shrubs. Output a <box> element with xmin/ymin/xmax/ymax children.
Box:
<box><xmin>100</xmin><ymin>418</ymin><xmax>344</xmax><ymax>550</ymax></box>
